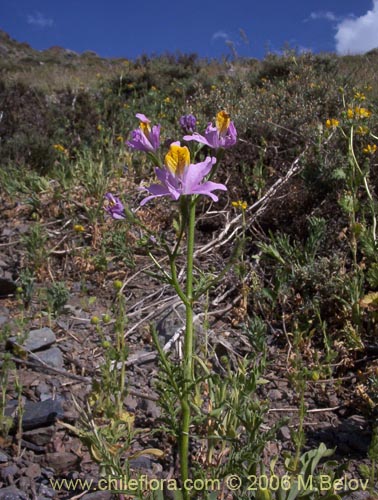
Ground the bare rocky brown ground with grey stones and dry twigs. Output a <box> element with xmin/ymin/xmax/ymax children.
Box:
<box><xmin>0</xmin><ymin>197</ymin><xmax>374</xmax><ymax>500</ymax></box>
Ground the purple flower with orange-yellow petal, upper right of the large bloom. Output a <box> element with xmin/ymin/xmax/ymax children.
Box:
<box><xmin>184</xmin><ymin>111</ymin><xmax>237</xmax><ymax>149</ymax></box>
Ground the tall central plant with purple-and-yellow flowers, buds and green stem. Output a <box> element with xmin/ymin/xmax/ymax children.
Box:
<box><xmin>104</xmin><ymin>111</ymin><xmax>237</xmax><ymax>500</ymax></box>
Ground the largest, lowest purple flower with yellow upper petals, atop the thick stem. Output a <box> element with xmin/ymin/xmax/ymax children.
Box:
<box><xmin>141</xmin><ymin>142</ymin><xmax>227</xmax><ymax>205</ymax></box>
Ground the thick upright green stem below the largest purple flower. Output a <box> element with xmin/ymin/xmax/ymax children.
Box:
<box><xmin>180</xmin><ymin>196</ymin><xmax>196</xmax><ymax>500</ymax></box>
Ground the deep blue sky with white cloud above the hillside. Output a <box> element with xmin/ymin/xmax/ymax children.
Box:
<box><xmin>0</xmin><ymin>0</ymin><xmax>378</xmax><ymax>59</ymax></box>
